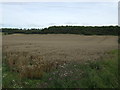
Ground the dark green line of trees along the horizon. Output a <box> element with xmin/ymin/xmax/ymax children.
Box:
<box><xmin>2</xmin><ymin>26</ymin><xmax>120</xmax><ymax>35</ymax></box>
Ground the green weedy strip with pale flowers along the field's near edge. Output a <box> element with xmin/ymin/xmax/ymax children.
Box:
<box><xmin>3</xmin><ymin>50</ymin><xmax>118</xmax><ymax>88</ymax></box>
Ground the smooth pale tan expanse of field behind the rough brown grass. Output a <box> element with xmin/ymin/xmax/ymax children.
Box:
<box><xmin>2</xmin><ymin>34</ymin><xmax>118</xmax><ymax>61</ymax></box>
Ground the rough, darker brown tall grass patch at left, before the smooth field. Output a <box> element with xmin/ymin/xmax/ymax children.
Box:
<box><xmin>3</xmin><ymin>52</ymin><xmax>64</xmax><ymax>78</ymax></box>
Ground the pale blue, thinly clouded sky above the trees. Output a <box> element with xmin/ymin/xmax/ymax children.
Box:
<box><xmin>0</xmin><ymin>2</ymin><xmax>118</xmax><ymax>28</ymax></box>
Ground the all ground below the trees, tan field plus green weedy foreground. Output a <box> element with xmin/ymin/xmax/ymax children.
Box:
<box><xmin>2</xmin><ymin>34</ymin><xmax>118</xmax><ymax>88</ymax></box>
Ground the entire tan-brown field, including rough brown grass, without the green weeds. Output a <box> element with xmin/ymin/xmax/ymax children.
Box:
<box><xmin>2</xmin><ymin>34</ymin><xmax>118</xmax><ymax>78</ymax></box>
